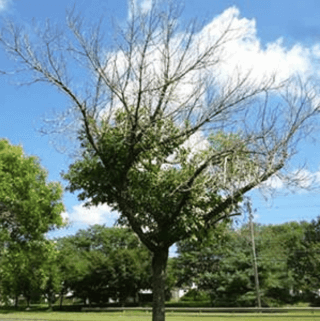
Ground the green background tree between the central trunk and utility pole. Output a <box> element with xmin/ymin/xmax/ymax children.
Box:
<box><xmin>176</xmin><ymin>224</ymin><xmax>255</xmax><ymax>306</ymax></box>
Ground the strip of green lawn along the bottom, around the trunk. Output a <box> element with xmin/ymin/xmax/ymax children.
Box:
<box><xmin>0</xmin><ymin>311</ymin><xmax>320</xmax><ymax>321</ymax></box>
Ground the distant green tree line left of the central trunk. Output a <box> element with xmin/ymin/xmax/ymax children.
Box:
<box><xmin>0</xmin><ymin>225</ymin><xmax>151</xmax><ymax>306</ymax></box>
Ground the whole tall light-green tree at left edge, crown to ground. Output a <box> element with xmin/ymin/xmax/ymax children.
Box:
<box><xmin>0</xmin><ymin>139</ymin><xmax>64</xmax><ymax>305</ymax></box>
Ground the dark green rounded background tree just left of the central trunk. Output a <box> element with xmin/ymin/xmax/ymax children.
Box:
<box><xmin>58</xmin><ymin>225</ymin><xmax>151</xmax><ymax>304</ymax></box>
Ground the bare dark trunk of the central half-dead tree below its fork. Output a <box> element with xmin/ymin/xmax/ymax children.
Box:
<box><xmin>152</xmin><ymin>248</ymin><xmax>169</xmax><ymax>321</ymax></box>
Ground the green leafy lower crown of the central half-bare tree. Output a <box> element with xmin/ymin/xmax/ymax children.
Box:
<box><xmin>64</xmin><ymin>108</ymin><xmax>254</xmax><ymax>251</ymax></box>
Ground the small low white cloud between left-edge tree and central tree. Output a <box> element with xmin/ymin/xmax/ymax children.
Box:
<box><xmin>62</xmin><ymin>204</ymin><xmax>119</xmax><ymax>225</ymax></box>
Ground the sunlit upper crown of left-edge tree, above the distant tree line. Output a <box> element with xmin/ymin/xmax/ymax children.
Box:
<box><xmin>0</xmin><ymin>139</ymin><xmax>64</xmax><ymax>241</ymax></box>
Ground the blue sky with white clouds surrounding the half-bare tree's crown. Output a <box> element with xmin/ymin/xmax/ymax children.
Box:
<box><xmin>0</xmin><ymin>0</ymin><xmax>320</xmax><ymax>252</ymax></box>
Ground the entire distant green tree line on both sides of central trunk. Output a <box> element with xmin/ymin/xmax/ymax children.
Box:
<box><xmin>0</xmin><ymin>219</ymin><xmax>320</xmax><ymax>306</ymax></box>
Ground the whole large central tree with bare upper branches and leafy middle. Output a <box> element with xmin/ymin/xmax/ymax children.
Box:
<box><xmin>0</xmin><ymin>1</ymin><xmax>318</xmax><ymax>321</ymax></box>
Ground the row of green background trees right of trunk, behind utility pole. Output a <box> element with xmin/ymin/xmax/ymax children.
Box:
<box><xmin>175</xmin><ymin>218</ymin><xmax>320</xmax><ymax>307</ymax></box>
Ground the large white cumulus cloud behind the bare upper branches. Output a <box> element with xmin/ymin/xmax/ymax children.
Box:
<box><xmin>109</xmin><ymin>5</ymin><xmax>320</xmax><ymax>124</ymax></box>
